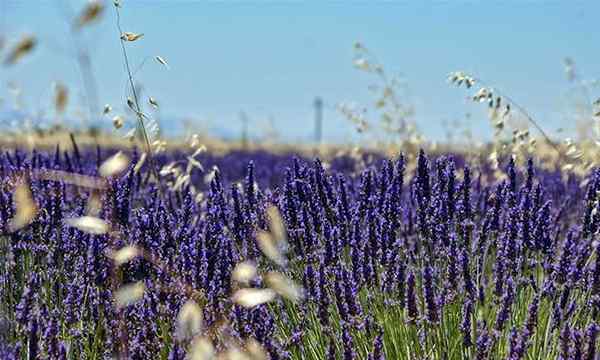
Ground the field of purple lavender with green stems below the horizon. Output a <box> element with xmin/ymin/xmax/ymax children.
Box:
<box><xmin>0</xmin><ymin>148</ymin><xmax>600</xmax><ymax>359</ymax></box>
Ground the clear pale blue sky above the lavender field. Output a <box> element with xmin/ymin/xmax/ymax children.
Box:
<box><xmin>0</xmin><ymin>0</ymin><xmax>600</xmax><ymax>141</ymax></box>
